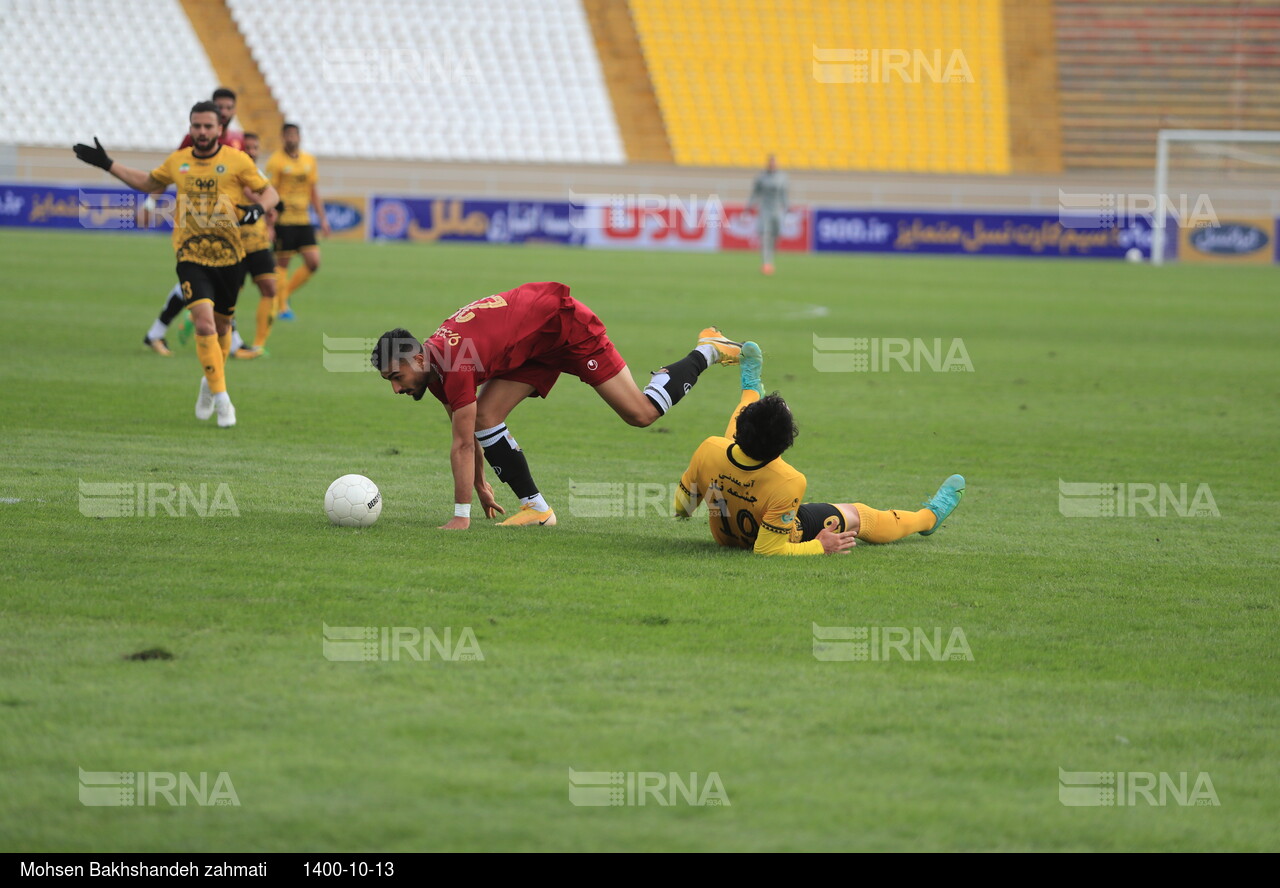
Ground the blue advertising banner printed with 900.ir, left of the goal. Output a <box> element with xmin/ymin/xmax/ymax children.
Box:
<box><xmin>813</xmin><ymin>207</ymin><xmax>1178</xmax><ymax>258</ymax></box>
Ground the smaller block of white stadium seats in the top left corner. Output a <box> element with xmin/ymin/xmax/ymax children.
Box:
<box><xmin>0</xmin><ymin>0</ymin><xmax>218</xmax><ymax>151</ymax></box>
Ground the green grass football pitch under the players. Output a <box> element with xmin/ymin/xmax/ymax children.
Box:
<box><xmin>0</xmin><ymin>232</ymin><xmax>1280</xmax><ymax>851</ymax></box>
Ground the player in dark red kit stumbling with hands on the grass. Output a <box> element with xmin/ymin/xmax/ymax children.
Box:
<box><xmin>372</xmin><ymin>283</ymin><xmax>741</xmax><ymax>530</ymax></box>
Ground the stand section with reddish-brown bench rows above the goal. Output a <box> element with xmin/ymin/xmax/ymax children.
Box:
<box><xmin>1056</xmin><ymin>0</ymin><xmax>1280</xmax><ymax>169</ymax></box>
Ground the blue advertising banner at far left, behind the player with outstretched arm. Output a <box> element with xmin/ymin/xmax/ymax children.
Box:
<box><xmin>0</xmin><ymin>184</ymin><xmax>174</xmax><ymax>232</ymax></box>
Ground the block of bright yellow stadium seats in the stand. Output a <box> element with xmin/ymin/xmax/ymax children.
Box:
<box><xmin>631</xmin><ymin>0</ymin><xmax>1010</xmax><ymax>173</ymax></box>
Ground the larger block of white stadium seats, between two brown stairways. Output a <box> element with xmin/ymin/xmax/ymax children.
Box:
<box><xmin>228</xmin><ymin>0</ymin><xmax>625</xmax><ymax>164</ymax></box>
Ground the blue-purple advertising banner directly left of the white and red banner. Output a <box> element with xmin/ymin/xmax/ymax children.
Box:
<box><xmin>371</xmin><ymin>197</ymin><xmax>585</xmax><ymax>244</ymax></box>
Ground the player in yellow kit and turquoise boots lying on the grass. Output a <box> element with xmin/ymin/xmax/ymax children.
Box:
<box><xmin>676</xmin><ymin>342</ymin><xmax>964</xmax><ymax>555</ymax></box>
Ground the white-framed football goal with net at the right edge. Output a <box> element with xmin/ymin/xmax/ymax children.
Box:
<box><xmin>1151</xmin><ymin>129</ymin><xmax>1280</xmax><ymax>265</ymax></box>
